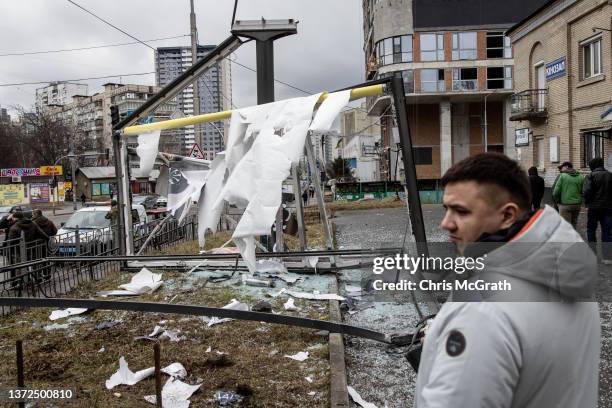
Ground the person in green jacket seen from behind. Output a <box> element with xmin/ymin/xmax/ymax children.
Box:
<box><xmin>553</xmin><ymin>162</ymin><xmax>584</xmax><ymax>228</ymax></box>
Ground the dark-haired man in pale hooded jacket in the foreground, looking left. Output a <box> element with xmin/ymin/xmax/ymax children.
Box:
<box><xmin>415</xmin><ymin>153</ymin><xmax>601</xmax><ymax>408</ymax></box>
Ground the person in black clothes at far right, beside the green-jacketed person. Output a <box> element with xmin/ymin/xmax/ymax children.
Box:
<box><xmin>582</xmin><ymin>157</ymin><xmax>612</xmax><ymax>265</ymax></box>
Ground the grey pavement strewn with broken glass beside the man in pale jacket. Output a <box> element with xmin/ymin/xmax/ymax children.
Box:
<box><xmin>332</xmin><ymin>205</ymin><xmax>612</xmax><ymax>408</ymax></box>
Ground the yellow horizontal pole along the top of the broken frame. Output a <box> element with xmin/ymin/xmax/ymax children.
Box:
<box><xmin>123</xmin><ymin>84</ymin><xmax>383</xmax><ymax>136</ymax></box>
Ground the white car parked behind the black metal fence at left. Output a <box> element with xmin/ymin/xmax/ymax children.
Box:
<box><xmin>52</xmin><ymin>204</ymin><xmax>149</xmax><ymax>255</ymax></box>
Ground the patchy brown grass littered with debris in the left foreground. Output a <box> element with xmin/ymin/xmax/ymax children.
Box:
<box><xmin>0</xmin><ymin>272</ymin><xmax>329</xmax><ymax>407</ymax></box>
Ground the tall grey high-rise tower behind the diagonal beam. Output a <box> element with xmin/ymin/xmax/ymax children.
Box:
<box><xmin>155</xmin><ymin>45</ymin><xmax>232</xmax><ymax>152</ymax></box>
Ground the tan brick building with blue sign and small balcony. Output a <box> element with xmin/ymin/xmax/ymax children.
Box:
<box><xmin>508</xmin><ymin>0</ymin><xmax>612</xmax><ymax>186</ymax></box>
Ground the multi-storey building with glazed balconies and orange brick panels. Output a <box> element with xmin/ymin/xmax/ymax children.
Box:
<box><xmin>363</xmin><ymin>0</ymin><xmax>544</xmax><ymax>185</ymax></box>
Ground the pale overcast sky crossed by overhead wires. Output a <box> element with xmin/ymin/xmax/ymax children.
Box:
<box><xmin>0</xmin><ymin>0</ymin><xmax>364</xmax><ymax>117</ymax></box>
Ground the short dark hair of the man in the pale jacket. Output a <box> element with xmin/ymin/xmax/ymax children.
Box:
<box><xmin>441</xmin><ymin>153</ymin><xmax>531</xmax><ymax>210</ymax></box>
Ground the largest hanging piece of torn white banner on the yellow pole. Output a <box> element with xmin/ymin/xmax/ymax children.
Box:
<box><xmin>198</xmin><ymin>91</ymin><xmax>350</xmax><ymax>272</ymax></box>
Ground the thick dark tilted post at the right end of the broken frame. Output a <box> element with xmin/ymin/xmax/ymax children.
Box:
<box><xmin>391</xmin><ymin>77</ymin><xmax>429</xmax><ymax>256</ymax></box>
